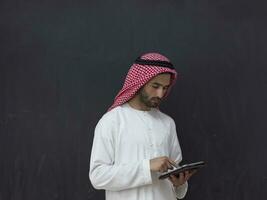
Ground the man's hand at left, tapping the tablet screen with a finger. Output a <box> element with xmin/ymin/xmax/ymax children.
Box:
<box><xmin>150</xmin><ymin>156</ymin><xmax>176</xmax><ymax>173</ymax></box>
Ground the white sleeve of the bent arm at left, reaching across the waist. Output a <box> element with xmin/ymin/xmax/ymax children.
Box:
<box><xmin>89</xmin><ymin>113</ymin><xmax>152</xmax><ymax>191</ymax></box>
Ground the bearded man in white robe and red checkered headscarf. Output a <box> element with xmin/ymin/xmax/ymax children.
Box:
<box><xmin>89</xmin><ymin>53</ymin><xmax>196</xmax><ymax>200</ymax></box>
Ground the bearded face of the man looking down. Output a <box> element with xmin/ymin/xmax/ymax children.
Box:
<box><xmin>139</xmin><ymin>73</ymin><xmax>171</xmax><ymax>108</ymax></box>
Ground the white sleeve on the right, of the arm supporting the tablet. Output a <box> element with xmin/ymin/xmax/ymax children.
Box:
<box><xmin>170</xmin><ymin>120</ymin><xmax>188</xmax><ymax>199</ymax></box>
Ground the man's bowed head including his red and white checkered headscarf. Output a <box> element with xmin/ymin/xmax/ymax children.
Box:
<box><xmin>109</xmin><ymin>53</ymin><xmax>180</xmax><ymax>110</ymax></box>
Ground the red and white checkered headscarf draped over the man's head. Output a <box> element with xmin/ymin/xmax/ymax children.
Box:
<box><xmin>108</xmin><ymin>53</ymin><xmax>177</xmax><ymax>111</ymax></box>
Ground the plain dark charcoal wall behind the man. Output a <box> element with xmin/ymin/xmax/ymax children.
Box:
<box><xmin>0</xmin><ymin>0</ymin><xmax>267</xmax><ymax>200</ymax></box>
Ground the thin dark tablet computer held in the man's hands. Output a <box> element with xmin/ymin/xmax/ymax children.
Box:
<box><xmin>159</xmin><ymin>161</ymin><xmax>205</xmax><ymax>179</ymax></box>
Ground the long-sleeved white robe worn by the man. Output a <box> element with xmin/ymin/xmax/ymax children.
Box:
<box><xmin>89</xmin><ymin>103</ymin><xmax>188</xmax><ymax>200</ymax></box>
